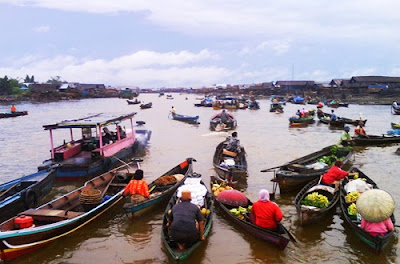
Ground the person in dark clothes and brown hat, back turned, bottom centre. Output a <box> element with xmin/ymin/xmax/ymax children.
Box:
<box><xmin>167</xmin><ymin>190</ymin><xmax>204</xmax><ymax>250</ymax></box>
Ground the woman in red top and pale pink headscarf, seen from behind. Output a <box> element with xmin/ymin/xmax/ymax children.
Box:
<box><xmin>251</xmin><ymin>189</ymin><xmax>283</xmax><ymax>231</ymax></box>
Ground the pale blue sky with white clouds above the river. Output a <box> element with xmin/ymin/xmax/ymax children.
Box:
<box><xmin>0</xmin><ymin>0</ymin><xmax>400</xmax><ymax>88</ymax></box>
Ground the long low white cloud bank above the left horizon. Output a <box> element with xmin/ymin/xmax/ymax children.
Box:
<box><xmin>0</xmin><ymin>50</ymin><xmax>228</xmax><ymax>87</ymax></box>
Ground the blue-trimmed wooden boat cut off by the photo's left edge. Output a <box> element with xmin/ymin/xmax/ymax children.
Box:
<box><xmin>0</xmin><ymin>168</ymin><xmax>56</xmax><ymax>222</ymax></box>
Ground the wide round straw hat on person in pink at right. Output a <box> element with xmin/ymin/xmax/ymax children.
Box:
<box><xmin>357</xmin><ymin>189</ymin><xmax>395</xmax><ymax>223</ymax></box>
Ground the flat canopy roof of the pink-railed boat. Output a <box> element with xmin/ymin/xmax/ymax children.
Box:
<box><xmin>43</xmin><ymin>112</ymin><xmax>136</xmax><ymax>130</ymax></box>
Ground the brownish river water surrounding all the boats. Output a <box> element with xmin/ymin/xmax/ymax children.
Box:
<box><xmin>0</xmin><ymin>94</ymin><xmax>400</xmax><ymax>264</ymax></box>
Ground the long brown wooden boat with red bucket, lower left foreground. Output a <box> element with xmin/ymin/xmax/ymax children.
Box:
<box><xmin>0</xmin><ymin>164</ymin><xmax>138</xmax><ymax>261</ymax></box>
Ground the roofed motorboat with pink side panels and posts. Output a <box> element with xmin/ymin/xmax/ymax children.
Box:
<box><xmin>40</xmin><ymin>113</ymin><xmax>151</xmax><ymax>180</ymax></box>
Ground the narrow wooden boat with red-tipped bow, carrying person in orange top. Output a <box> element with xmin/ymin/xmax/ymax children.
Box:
<box><xmin>124</xmin><ymin>158</ymin><xmax>196</xmax><ymax>217</ymax></box>
